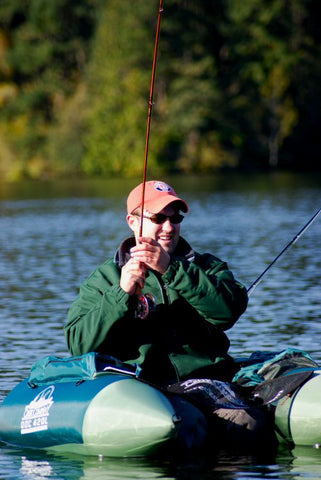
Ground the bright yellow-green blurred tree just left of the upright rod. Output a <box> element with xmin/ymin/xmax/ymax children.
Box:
<box><xmin>82</xmin><ymin>0</ymin><xmax>157</xmax><ymax>175</ymax></box>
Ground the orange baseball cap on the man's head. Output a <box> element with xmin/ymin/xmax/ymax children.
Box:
<box><xmin>127</xmin><ymin>180</ymin><xmax>188</xmax><ymax>213</ymax></box>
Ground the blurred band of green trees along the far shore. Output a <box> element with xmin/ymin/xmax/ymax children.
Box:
<box><xmin>0</xmin><ymin>0</ymin><xmax>321</xmax><ymax>178</ymax></box>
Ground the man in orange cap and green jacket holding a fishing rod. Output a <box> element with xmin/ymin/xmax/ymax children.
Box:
<box><xmin>65</xmin><ymin>181</ymin><xmax>247</xmax><ymax>385</ymax></box>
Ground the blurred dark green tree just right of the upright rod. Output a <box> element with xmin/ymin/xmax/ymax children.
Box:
<box><xmin>155</xmin><ymin>0</ymin><xmax>236</xmax><ymax>172</ymax></box>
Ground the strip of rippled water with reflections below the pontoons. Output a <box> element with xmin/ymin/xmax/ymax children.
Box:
<box><xmin>1</xmin><ymin>448</ymin><xmax>321</xmax><ymax>480</ymax></box>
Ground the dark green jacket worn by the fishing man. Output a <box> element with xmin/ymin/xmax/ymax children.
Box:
<box><xmin>65</xmin><ymin>237</ymin><xmax>247</xmax><ymax>384</ymax></box>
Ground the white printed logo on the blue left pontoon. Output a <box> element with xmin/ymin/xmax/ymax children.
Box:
<box><xmin>21</xmin><ymin>385</ymin><xmax>55</xmax><ymax>434</ymax></box>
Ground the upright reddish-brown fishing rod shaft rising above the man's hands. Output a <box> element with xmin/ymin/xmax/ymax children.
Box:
<box><xmin>139</xmin><ymin>0</ymin><xmax>163</xmax><ymax>237</ymax></box>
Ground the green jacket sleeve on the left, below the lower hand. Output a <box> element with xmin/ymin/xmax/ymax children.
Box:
<box><xmin>64</xmin><ymin>261</ymin><xmax>130</xmax><ymax>355</ymax></box>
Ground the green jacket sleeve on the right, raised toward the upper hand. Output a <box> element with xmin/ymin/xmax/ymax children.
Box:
<box><xmin>163</xmin><ymin>254</ymin><xmax>248</xmax><ymax>330</ymax></box>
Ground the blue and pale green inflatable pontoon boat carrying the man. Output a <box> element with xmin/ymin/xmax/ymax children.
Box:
<box><xmin>0</xmin><ymin>350</ymin><xmax>321</xmax><ymax>457</ymax></box>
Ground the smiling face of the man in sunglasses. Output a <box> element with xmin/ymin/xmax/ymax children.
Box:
<box><xmin>127</xmin><ymin>204</ymin><xmax>180</xmax><ymax>254</ymax></box>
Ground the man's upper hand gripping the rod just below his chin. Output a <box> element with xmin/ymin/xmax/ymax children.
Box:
<box><xmin>130</xmin><ymin>237</ymin><xmax>170</xmax><ymax>275</ymax></box>
